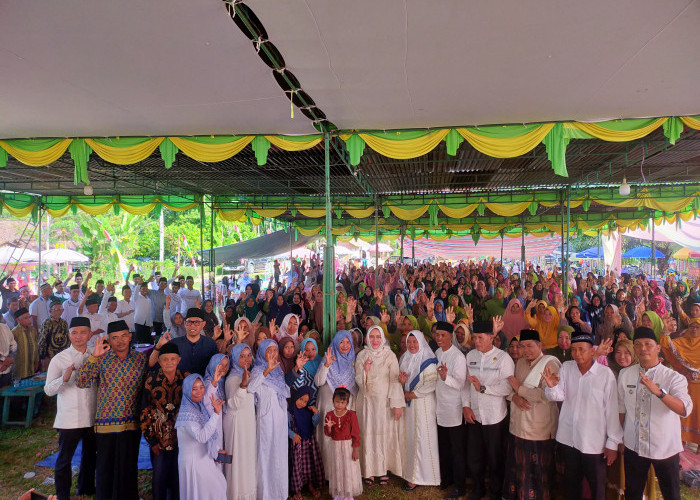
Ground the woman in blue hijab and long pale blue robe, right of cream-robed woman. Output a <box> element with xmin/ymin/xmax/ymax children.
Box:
<box><xmin>248</xmin><ymin>339</ymin><xmax>290</xmax><ymax>500</ymax></box>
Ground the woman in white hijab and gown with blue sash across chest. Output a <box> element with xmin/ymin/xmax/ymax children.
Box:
<box><xmin>399</xmin><ymin>330</ymin><xmax>440</xmax><ymax>491</ymax></box>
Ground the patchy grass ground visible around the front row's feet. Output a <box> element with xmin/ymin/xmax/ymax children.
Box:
<box><xmin>0</xmin><ymin>399</ymin><xmax>700</xmax><ymax>500</ymax></box>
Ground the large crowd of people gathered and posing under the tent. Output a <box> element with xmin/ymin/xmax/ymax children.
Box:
<box><xmin>0</xmin><ymin>258</ymin><xmax>700</xmax><ymax>500</ymax></box>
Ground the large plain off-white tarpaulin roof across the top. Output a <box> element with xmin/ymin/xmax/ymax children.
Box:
<box><xmin>0</xmin><ymin>0</ymin><xmax>700</xmax><ymax>138</ymax></box>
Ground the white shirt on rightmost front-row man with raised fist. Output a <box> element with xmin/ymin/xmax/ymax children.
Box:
<box><xmin>617</xmin><ymin>363</ymin><xmax>693</xmax><ymax>460</ymax></box>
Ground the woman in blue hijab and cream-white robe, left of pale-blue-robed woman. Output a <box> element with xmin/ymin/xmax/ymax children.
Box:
<box><xmin>223</xmin><ymin>344</ymin><xmax>257</xmax><ymax>500</ymax></box>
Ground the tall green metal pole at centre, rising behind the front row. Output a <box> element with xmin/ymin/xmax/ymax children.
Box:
<box><xmin>323</xmin><ymin>136</ymin><xmax>336</xmax><ymax>346</ymax></box>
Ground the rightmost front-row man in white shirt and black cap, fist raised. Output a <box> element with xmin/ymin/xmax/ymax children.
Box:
<box><xmin>617</xmin><ymin>326</ymin><xmax>693</xmax><ymax>500</ymax></box>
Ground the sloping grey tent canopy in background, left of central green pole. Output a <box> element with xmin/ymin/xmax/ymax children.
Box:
<box><xmin>202</xmin><ymin>231</ymin><xmax>318</xmax><ymax>265</ymax></box>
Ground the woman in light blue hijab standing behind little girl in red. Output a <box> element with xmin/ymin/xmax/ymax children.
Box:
<box><xmin>314</xmin><ymin>330</ymin><xmax>357</xmax><ymax>477</ymax></box>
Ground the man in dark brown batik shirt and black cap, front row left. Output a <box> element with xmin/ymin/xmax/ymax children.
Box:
<box><xmin>141</xmin><ymin>342</ymin><xmax>185</xmax><ymax>500</ymax></box>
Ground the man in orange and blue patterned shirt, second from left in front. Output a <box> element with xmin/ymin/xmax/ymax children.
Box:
<box><xmin>76</xmin><ymin>320</ymin><xmax>146</xmax><ymax>500</ymax></box>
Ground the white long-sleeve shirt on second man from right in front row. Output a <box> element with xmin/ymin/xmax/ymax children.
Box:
<box><xmin>544</xmin><ymin>361</ymin><xmax>622</xmax><ymax>455</ymax></box>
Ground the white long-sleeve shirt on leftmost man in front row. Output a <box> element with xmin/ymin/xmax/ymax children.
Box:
<box><xmin>44</xmin><ymin>346</ymin><xmax>97</xmax><ymax>429</ymax></box>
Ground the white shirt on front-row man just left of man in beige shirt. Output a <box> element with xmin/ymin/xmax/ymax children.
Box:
<box><xmin>466</xmin><ymin>347</ymin><xmax>515</xmax><ymax>425</ymax></box>
